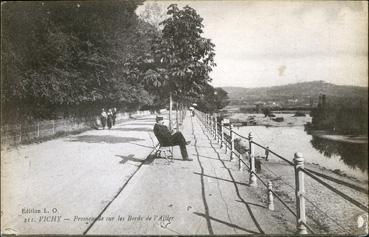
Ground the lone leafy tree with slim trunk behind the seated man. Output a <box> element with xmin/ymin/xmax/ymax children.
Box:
<box><xmin>141</xmin><ymin>4</ymin><xmax>216</xmax><ymax>129</ymax></box>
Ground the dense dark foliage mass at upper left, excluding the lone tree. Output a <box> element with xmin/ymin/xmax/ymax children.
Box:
<box><xmin>1</xmin><ymin>1</ymin><xmax>156</xmax><ymax>121</ymax></box>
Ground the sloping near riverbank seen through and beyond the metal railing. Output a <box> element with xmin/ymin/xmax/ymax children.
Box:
<box><xmin>198</xmin><ymin>114</ymin><xmax>368</xmax><ymax>235</ymax></box>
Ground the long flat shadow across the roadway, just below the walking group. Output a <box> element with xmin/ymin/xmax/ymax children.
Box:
<box><xmin>69</xmin><ymin>135</ymin><xmax>144</xmax><ymax>144</ymax></box>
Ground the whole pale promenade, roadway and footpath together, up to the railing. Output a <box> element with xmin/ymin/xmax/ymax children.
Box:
<box><xmin>1</xmin><ymin>113</ymin><xmax>295</xmax><ymax>235</ymax></box>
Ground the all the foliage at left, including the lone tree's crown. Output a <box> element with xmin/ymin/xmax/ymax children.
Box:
<box><xmin>1</xmin><ymin>0</ymin><xmax>215</xmax><ymax>121</ymax></box>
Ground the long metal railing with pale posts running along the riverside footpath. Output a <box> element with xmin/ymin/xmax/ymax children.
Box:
<box><xmin>196</xmin><ymin>110</ymin><xmax>368</xmax><ymax>234</ymax></box>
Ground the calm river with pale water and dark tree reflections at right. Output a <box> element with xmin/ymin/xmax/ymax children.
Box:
<box><xmin>229</xmin><ymin>115</ymin><xmax>368</xmax><ymax>180</ymax></box>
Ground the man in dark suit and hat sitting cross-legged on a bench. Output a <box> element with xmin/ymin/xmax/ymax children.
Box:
<box><xmin>154</xmin><ymin>117</ymin><xmax>192</xmax><ymax>161</ymax></box>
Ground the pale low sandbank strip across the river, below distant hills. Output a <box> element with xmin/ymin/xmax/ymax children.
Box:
<box><xmin>228</xmin><ymin>113</ymin><xmax>311</xmax><ymax>127</ymax></box>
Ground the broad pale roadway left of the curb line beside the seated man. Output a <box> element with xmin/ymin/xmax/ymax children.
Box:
<box><xmin>1</xmin><ymin>115</ymin><xmax>156</xmax><ymax>234</ymax></box>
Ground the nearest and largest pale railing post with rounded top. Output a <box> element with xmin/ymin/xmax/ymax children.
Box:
<box><xmin>293</xmin><ymin>152</ymin><xmax>307</xmax><ymax>234</ymax></box>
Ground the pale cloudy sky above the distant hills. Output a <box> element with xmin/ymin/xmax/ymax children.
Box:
<box><xmin>137</xmin><ymin>1</ymin><xmax>368</xmax><ymax>88</ymax></box>
